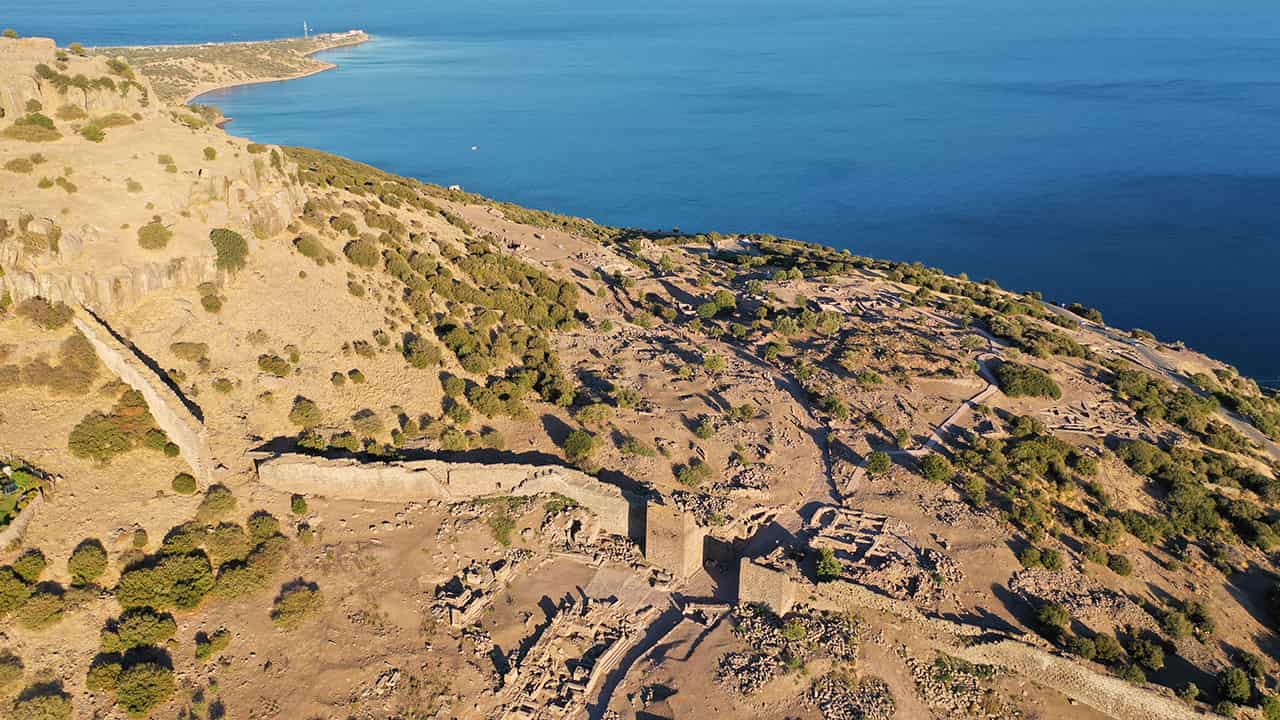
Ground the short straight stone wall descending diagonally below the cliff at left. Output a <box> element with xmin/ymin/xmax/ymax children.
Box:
<box><xmin>74</xmin><ymin>311</ymin><xmax>211</xmax><ymax>483</ymax></box>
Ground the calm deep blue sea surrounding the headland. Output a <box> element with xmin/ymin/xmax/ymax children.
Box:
<box><xmin>10</xmin><ymin>0</ymin><xmax>1280</xmax><ymax>382</ymax></box>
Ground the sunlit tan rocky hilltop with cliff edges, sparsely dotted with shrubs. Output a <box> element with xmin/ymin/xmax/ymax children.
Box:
<box><xmin>0</xmin><ymin>38</ymin><xmax>306</xmax><ymax>310</ymax></box>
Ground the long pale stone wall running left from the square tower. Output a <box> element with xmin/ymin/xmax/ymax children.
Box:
<box><xmin>257</xmin><ymin>455</ymin><xmax>631</xmax><ymax>536</ymax></box>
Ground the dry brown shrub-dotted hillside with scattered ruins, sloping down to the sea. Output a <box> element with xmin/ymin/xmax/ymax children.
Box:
<box><xmin>0</xmin><ymin>30</ymin><xmax>1280</xmax><ymax>720</ymax></box>
